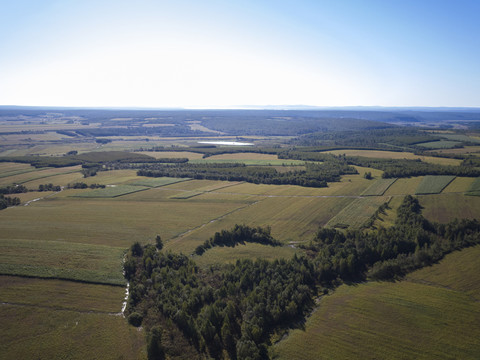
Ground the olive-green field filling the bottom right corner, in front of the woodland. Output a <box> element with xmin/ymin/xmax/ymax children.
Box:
<box><xmin>274</xmin><ymin>248</ymin><xmax>480</xmax><ymax>359</ymax></box>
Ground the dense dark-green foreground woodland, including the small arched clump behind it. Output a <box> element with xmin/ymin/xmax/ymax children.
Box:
<box><xmin>124</xmin><ymin>196</ymin><xmax>480</xmax><ymax>359</ymax></box>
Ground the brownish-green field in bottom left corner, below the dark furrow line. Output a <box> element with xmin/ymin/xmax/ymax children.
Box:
<box><xmin>0</xmin><ymin>304</ymin><xmax>146</xmax><ymax>360</ymax></box>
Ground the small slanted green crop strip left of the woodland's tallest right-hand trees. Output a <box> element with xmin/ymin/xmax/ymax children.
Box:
<box><xmin>327</xmin><ymin>196</ymin><xmax>389</xmax><ymax>229</ymax></box>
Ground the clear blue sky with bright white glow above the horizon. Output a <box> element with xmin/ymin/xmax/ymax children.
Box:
<box><xmin>0</xmin><ymin>0</ymin><xmax>480</xmax><ymax>108</ymax></box>
